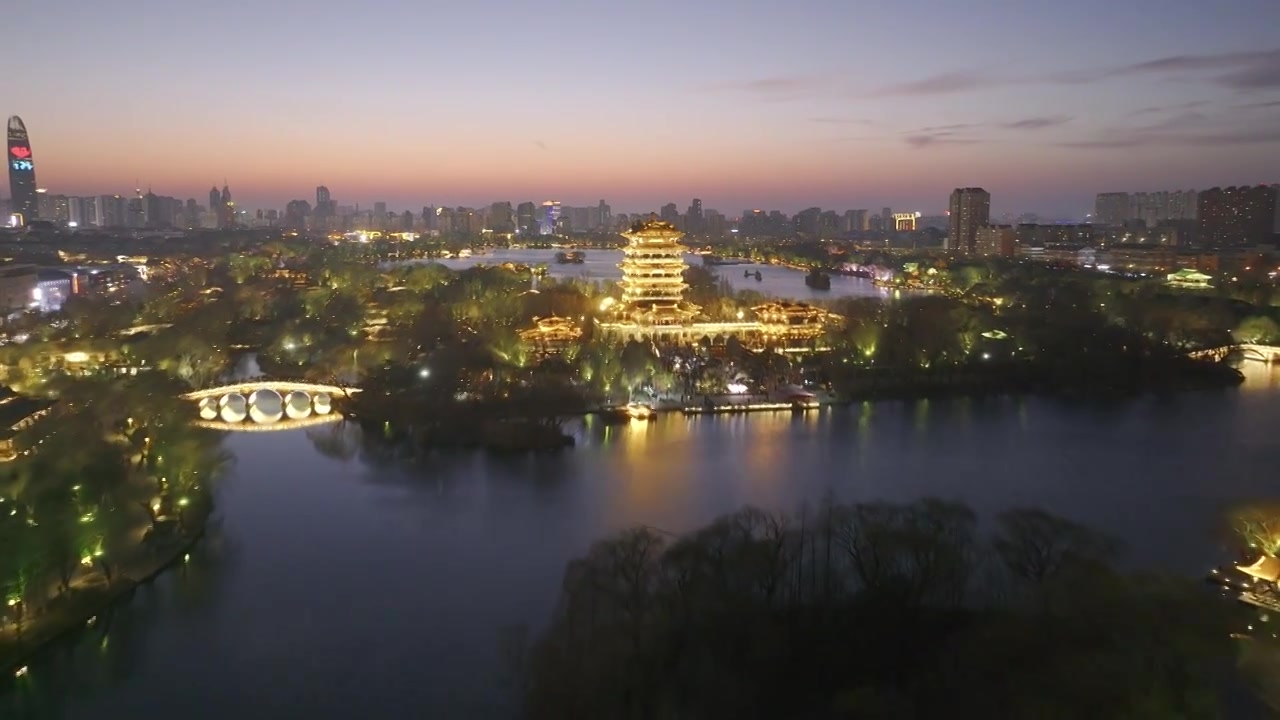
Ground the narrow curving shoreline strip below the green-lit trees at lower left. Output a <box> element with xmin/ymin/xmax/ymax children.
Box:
<box><xmin>0</xmin><ymin>518</ymin><xmax>207</xmax><ymax>688</ymax></box>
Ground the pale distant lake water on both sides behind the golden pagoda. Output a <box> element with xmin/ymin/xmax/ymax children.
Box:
<box><xmin>440</xmin><ymin>250</ymin><xmax>892</xmax><ymax>301</ymax></box>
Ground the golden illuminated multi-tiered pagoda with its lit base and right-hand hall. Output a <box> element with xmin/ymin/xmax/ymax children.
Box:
<box><xmin>598</xmin><ymin>220</ymin><xmax>840</xmax><ymax>351</ymax></box>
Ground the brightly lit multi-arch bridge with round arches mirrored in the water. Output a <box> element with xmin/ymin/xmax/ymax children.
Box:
<box><xmin>182</xmin><ymin>380</ymin><xmax>360</xmax><ymax>430</ymax></box>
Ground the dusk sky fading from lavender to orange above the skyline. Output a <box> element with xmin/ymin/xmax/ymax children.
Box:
<box><xmin>0</xmin><ymin>0</ymin><xmax>1280</xmax><ymax>217</ymax></box>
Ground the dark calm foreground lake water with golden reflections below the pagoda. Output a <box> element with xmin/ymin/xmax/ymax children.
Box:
<box><xmin>0</xmin><ymin>364</ymin><xmax>1280</xmax><ymax>720</ymax></box>
